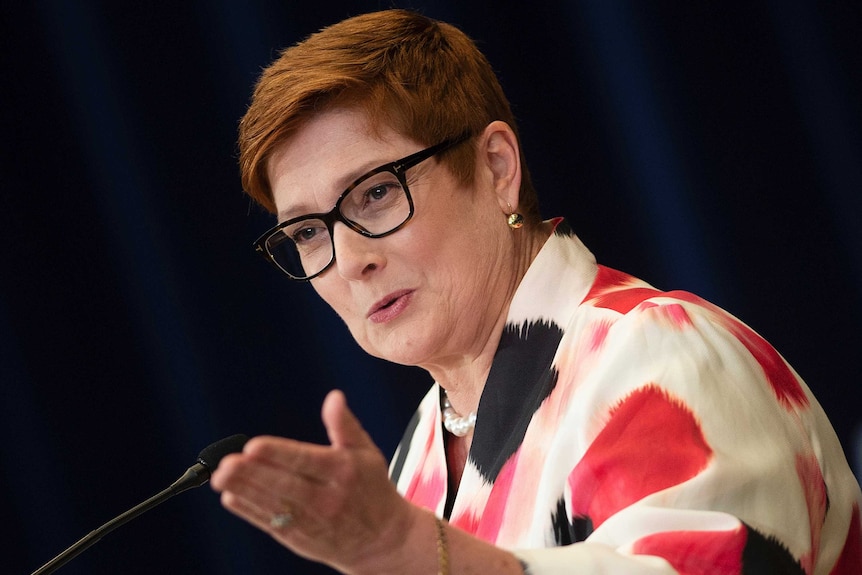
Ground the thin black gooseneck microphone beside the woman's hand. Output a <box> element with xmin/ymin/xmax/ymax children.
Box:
<box><xmin>32</xmin><ymin>433</ymin><xmax>248</xmax><ymax>575</ymax></box>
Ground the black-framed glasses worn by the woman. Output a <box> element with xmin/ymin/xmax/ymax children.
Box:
<box><xmin>254</xmin><ymin>134</ymin><xmax>470</xmax><ymax>281</ymax></box>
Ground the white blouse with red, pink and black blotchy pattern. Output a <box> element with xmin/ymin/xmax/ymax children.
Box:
<box><xmin>390</xmin><ymin>219</ymin><xmax>862</xmax><ymax>575</ymax></box>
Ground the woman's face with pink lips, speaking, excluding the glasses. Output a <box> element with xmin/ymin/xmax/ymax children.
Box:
<box><xmin>267</xmin><ymin>109</ymin><xmax>514</xmax><ymax>369</ymax></box>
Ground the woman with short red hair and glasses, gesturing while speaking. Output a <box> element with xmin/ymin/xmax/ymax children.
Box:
<box><xmin>212</xmin><ymin>10</ymin><xmax>862</xmax><ymax>574</ymax></box>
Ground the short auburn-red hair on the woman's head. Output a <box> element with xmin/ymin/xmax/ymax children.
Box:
<box><xmin>239</xmin><ymin>10</ymin><xmax>539</xmax><ymax>221</ymax></box>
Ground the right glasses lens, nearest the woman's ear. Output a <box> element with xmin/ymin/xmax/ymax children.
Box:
<box><xmin>339</xmin><ymin>172</ymin><xmax>410</xmax><ymax>236</ymax></box>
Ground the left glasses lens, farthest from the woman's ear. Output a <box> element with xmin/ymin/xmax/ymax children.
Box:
<box><xmin>266</xmin><ymin>218</ymin><xmax>332</xmax><ymax>279</ymax></box>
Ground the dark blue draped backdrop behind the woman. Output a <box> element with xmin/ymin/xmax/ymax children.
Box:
<box><xmin>0</xmin><ymin>0</ymin><xmax>862</xmax><ymax>575</ymax></box>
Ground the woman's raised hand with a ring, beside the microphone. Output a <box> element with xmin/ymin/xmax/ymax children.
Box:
<box><xmin>211</xmin><ymin>391</ymin><xmax>426</xmax><ymax>573</ymax></box>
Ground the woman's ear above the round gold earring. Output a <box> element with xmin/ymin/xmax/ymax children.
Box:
<box><xmin>479</xmin><ymin>120</ymin><xmax>521</xmax><ymax>214</ymax></box>
